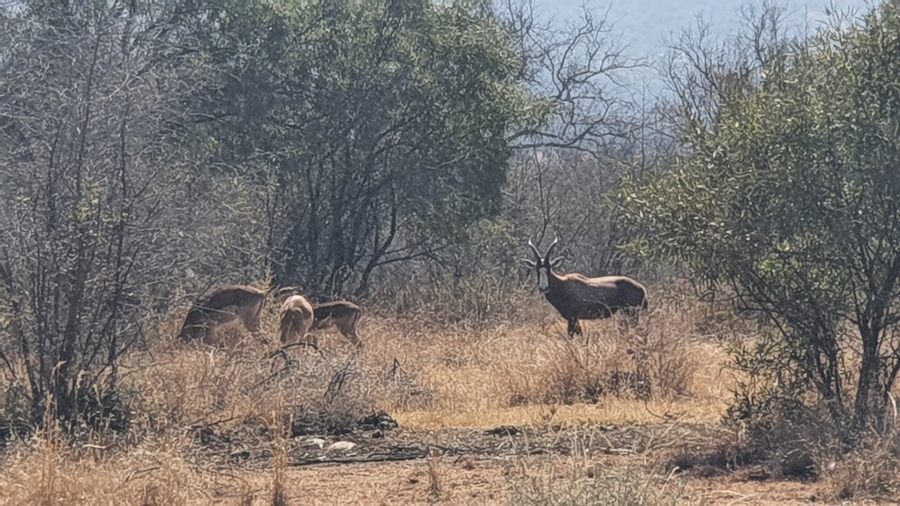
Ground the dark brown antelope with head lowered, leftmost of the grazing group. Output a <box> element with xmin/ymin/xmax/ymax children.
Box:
<box><xmin>178</xmin><ymin>285</ymin><xmax>266</xmax><ymax>344</ymax></box>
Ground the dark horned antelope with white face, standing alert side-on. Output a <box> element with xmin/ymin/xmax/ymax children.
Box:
<box><xmin>522</xmin><ymin>237</ymin><xmax>647</xmax><ymax>338</ymax></box>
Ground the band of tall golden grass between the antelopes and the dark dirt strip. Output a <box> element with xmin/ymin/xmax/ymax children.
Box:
<box><xmin>122</xmin><ymin>292</ymin><xmax>730</xmax><ymax>431</ymax></box>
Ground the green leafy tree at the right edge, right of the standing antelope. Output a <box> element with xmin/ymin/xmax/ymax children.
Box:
<box><xmin>625</xmin><ymin>0</ymin><xmax>900</xmax><ymax>434</ymax></box>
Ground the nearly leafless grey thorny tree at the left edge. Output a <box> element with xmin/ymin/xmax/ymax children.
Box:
<box><xmin>0</xmin><ymin>1</ymin><xmax>200</xmax><ymax>427</ymax></box>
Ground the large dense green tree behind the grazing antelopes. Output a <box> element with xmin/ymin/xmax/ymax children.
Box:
<box><xmin>190</xmin><ymin>0</ymin><xmax>550</xmax><ymax>292</ymax></box>
